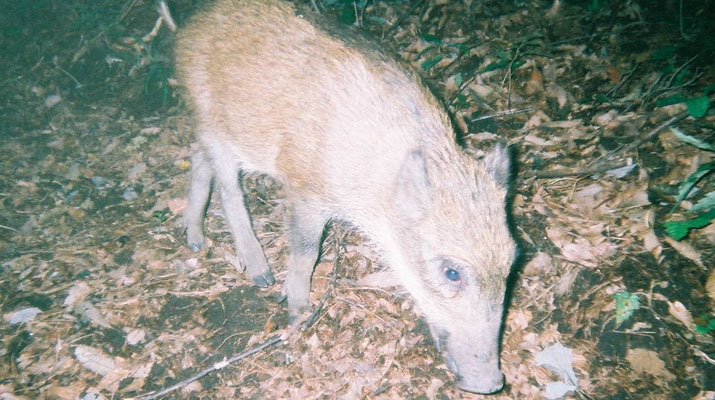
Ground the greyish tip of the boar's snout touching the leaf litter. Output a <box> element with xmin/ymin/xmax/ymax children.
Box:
<box><xmin>447</xmin><ymin>354</ymin><xmax>504</xmax><ymax>394</ymax></box>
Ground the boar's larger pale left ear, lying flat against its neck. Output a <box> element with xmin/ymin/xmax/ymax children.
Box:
<box><xmin>392</xmin><ymin>151</ymin><xmax>432</xmax><ymax>222</ymax></box>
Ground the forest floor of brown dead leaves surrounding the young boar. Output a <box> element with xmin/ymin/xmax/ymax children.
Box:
<box><xmin>0</xmin><ymin>0</ymin><xmax>715</xmax><ymax>400</ymax></box>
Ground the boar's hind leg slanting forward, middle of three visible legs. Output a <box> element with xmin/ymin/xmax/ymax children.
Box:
<box><xmin>212</xmin><ymin>151</ymin><xmax>275</xmax><ymax>287</ymax></box>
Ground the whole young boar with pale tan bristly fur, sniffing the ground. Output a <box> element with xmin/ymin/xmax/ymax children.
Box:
<box><xmin>176</xmin><ymin>0</ymin><xmax>515</xmax><ymax>393</ymax></box>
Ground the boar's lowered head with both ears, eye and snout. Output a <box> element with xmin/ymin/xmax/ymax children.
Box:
<box><xmin>386</xmin><ymin>146</ymin><xmax>516</xmax><ymax>393</ymax></box>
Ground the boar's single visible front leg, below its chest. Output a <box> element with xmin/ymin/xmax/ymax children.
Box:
<box><xmin>283</xmin><ymin>205</ymin><xmax>326</xmax><ymax>323</ymax></box>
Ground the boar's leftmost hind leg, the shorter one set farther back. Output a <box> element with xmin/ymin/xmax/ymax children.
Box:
<box><xmin>184</xmin><ymin>150</ymin><xmax>213</xmax><ymax>251</ymax></box>
